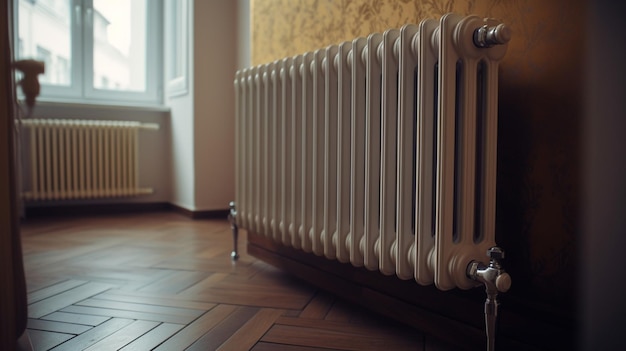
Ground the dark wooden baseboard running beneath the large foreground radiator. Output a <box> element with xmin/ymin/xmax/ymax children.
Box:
<box><xmin>247</xmin><ymin>232</ymin><xmax>577</xmax><ymax>350</ymax></box>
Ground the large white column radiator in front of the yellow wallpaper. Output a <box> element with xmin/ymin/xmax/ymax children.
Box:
<box><xmin>234</xmin><ymin>14</ymin><xmax>510</xmax><ymax>290</ymax></box>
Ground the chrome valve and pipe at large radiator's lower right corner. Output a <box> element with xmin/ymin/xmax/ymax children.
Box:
<box><xmin>467</xmin><ymin>246</ymin><xmax>511</xmax><ymax>351</ymax></box>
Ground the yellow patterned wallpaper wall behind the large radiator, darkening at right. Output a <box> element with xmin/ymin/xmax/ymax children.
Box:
<box><xmin>251</xmin><ymin>0</ymin><xmax>586</xmax><ymax>313</ymax></box>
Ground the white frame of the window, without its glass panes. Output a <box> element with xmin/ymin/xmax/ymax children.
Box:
<box><xmin>14</xmin><ymin>0</ymin><xmax>163</xmax><ymax>105</ymax></box>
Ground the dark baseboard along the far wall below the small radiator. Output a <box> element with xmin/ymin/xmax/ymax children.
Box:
<box><xmin>24</xmin><ymin>202</ymin><xmax>229</xmax><ymax>219</ymax></box>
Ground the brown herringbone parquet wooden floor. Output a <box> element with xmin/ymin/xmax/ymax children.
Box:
<box><xmin>17</xmin><ymin>212</ymin><xmax>449</xmax><ymax>351</ymax></box>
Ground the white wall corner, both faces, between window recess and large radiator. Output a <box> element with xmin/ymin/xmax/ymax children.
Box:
<box><xmin>166</xmin><ymin>0</ymin><xmax>238</xmax><ymax>211</ymax></box>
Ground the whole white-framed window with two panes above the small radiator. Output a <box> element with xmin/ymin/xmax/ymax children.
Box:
<box><xmin>15</xmin><ymin>0</ymin><xmax>162</xmax><ymax>103</ymax></box>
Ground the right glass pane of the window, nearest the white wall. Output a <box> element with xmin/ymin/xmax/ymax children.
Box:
<box><xmin>93</xmin><ymin>0</ymin><xmax>147</xmax><ymax>92</ymax></box>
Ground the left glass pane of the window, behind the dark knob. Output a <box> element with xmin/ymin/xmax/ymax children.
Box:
<box><xmin>17</xmin><ymin>0</ymin><xmax>72</xmax><ymax>86</ymax></box>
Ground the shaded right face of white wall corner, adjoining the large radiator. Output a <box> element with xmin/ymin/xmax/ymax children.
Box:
<box><xmin>193</xmin><ymin>0</ymin><xmax>237</xmax><ymax>210</ymax></box>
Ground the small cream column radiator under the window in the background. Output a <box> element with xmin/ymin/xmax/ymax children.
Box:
<box><xmin>21</xmin><ymin>119</ymin><xmax>158</xmax><ymax>201</ymax></box>
